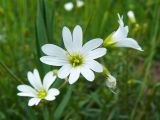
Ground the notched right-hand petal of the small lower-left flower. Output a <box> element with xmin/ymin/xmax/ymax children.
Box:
<box><xmin>45</xmin><ymin>88</ymin><xmax>60</xmax><ymax>101</ymax></box>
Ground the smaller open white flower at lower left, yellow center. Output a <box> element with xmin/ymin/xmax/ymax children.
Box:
<box><xmin>17</xmin><ymin>69</ymin><xmax>60</xmax><ymax>106</ymax></box>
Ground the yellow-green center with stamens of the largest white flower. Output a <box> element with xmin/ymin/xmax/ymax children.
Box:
<box><xmin>69</xmin><ymin>54</ymin><xmax>84</xmax><ymax>67</ymax></box>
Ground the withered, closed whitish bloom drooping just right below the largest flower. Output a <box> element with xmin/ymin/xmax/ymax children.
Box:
<box><xmin>106</xmin><ymin>74</ymin><xmax>117</xmax><ymax>89</ymax></box>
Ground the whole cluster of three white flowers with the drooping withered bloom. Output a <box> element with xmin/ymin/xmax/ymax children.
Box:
<box><xmin>17</xmin><ymin>15</ymin><xmax>142</xmax><ymax>106</ymax></box>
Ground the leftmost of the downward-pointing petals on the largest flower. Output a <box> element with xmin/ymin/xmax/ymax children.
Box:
<box><xmin>58</xmin><ymin>64</ymin><xmax>72</xmax><ymax>79</ymax></box>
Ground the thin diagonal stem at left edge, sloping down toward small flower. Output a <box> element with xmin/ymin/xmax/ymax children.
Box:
<box><xmin>0</xmin><ymin>61</ymin><xmax>23</xmax><ymax>83</ymax></box>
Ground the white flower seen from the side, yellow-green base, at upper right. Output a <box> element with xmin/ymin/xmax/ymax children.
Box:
<box><xmin>103</xmin><ymin>14</ymin><xmax>143</xmax><ymax>51</ymax></box>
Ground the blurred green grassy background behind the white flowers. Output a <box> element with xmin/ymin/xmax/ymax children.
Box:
<box><xmin>0</xmin><ymin>0</ymin><xmax>160</xmax><ymax>120</ymax></box>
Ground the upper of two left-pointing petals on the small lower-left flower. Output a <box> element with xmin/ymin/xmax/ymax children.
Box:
<box><xmin>17</xmin><ymin>85</ymin><xmax>36</xmax><ymax>94</ymax></box>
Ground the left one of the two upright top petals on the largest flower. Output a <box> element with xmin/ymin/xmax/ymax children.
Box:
<box><xmin>62</xmin><ymin>27</ymin><xmax>73</xmax><ymax>53</ymax></box>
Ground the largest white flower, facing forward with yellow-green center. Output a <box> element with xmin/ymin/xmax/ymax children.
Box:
<box><xmin>40</xmin><ymin>25</ymin><xmax>106</xmax><ymax>84</ymax></box>
